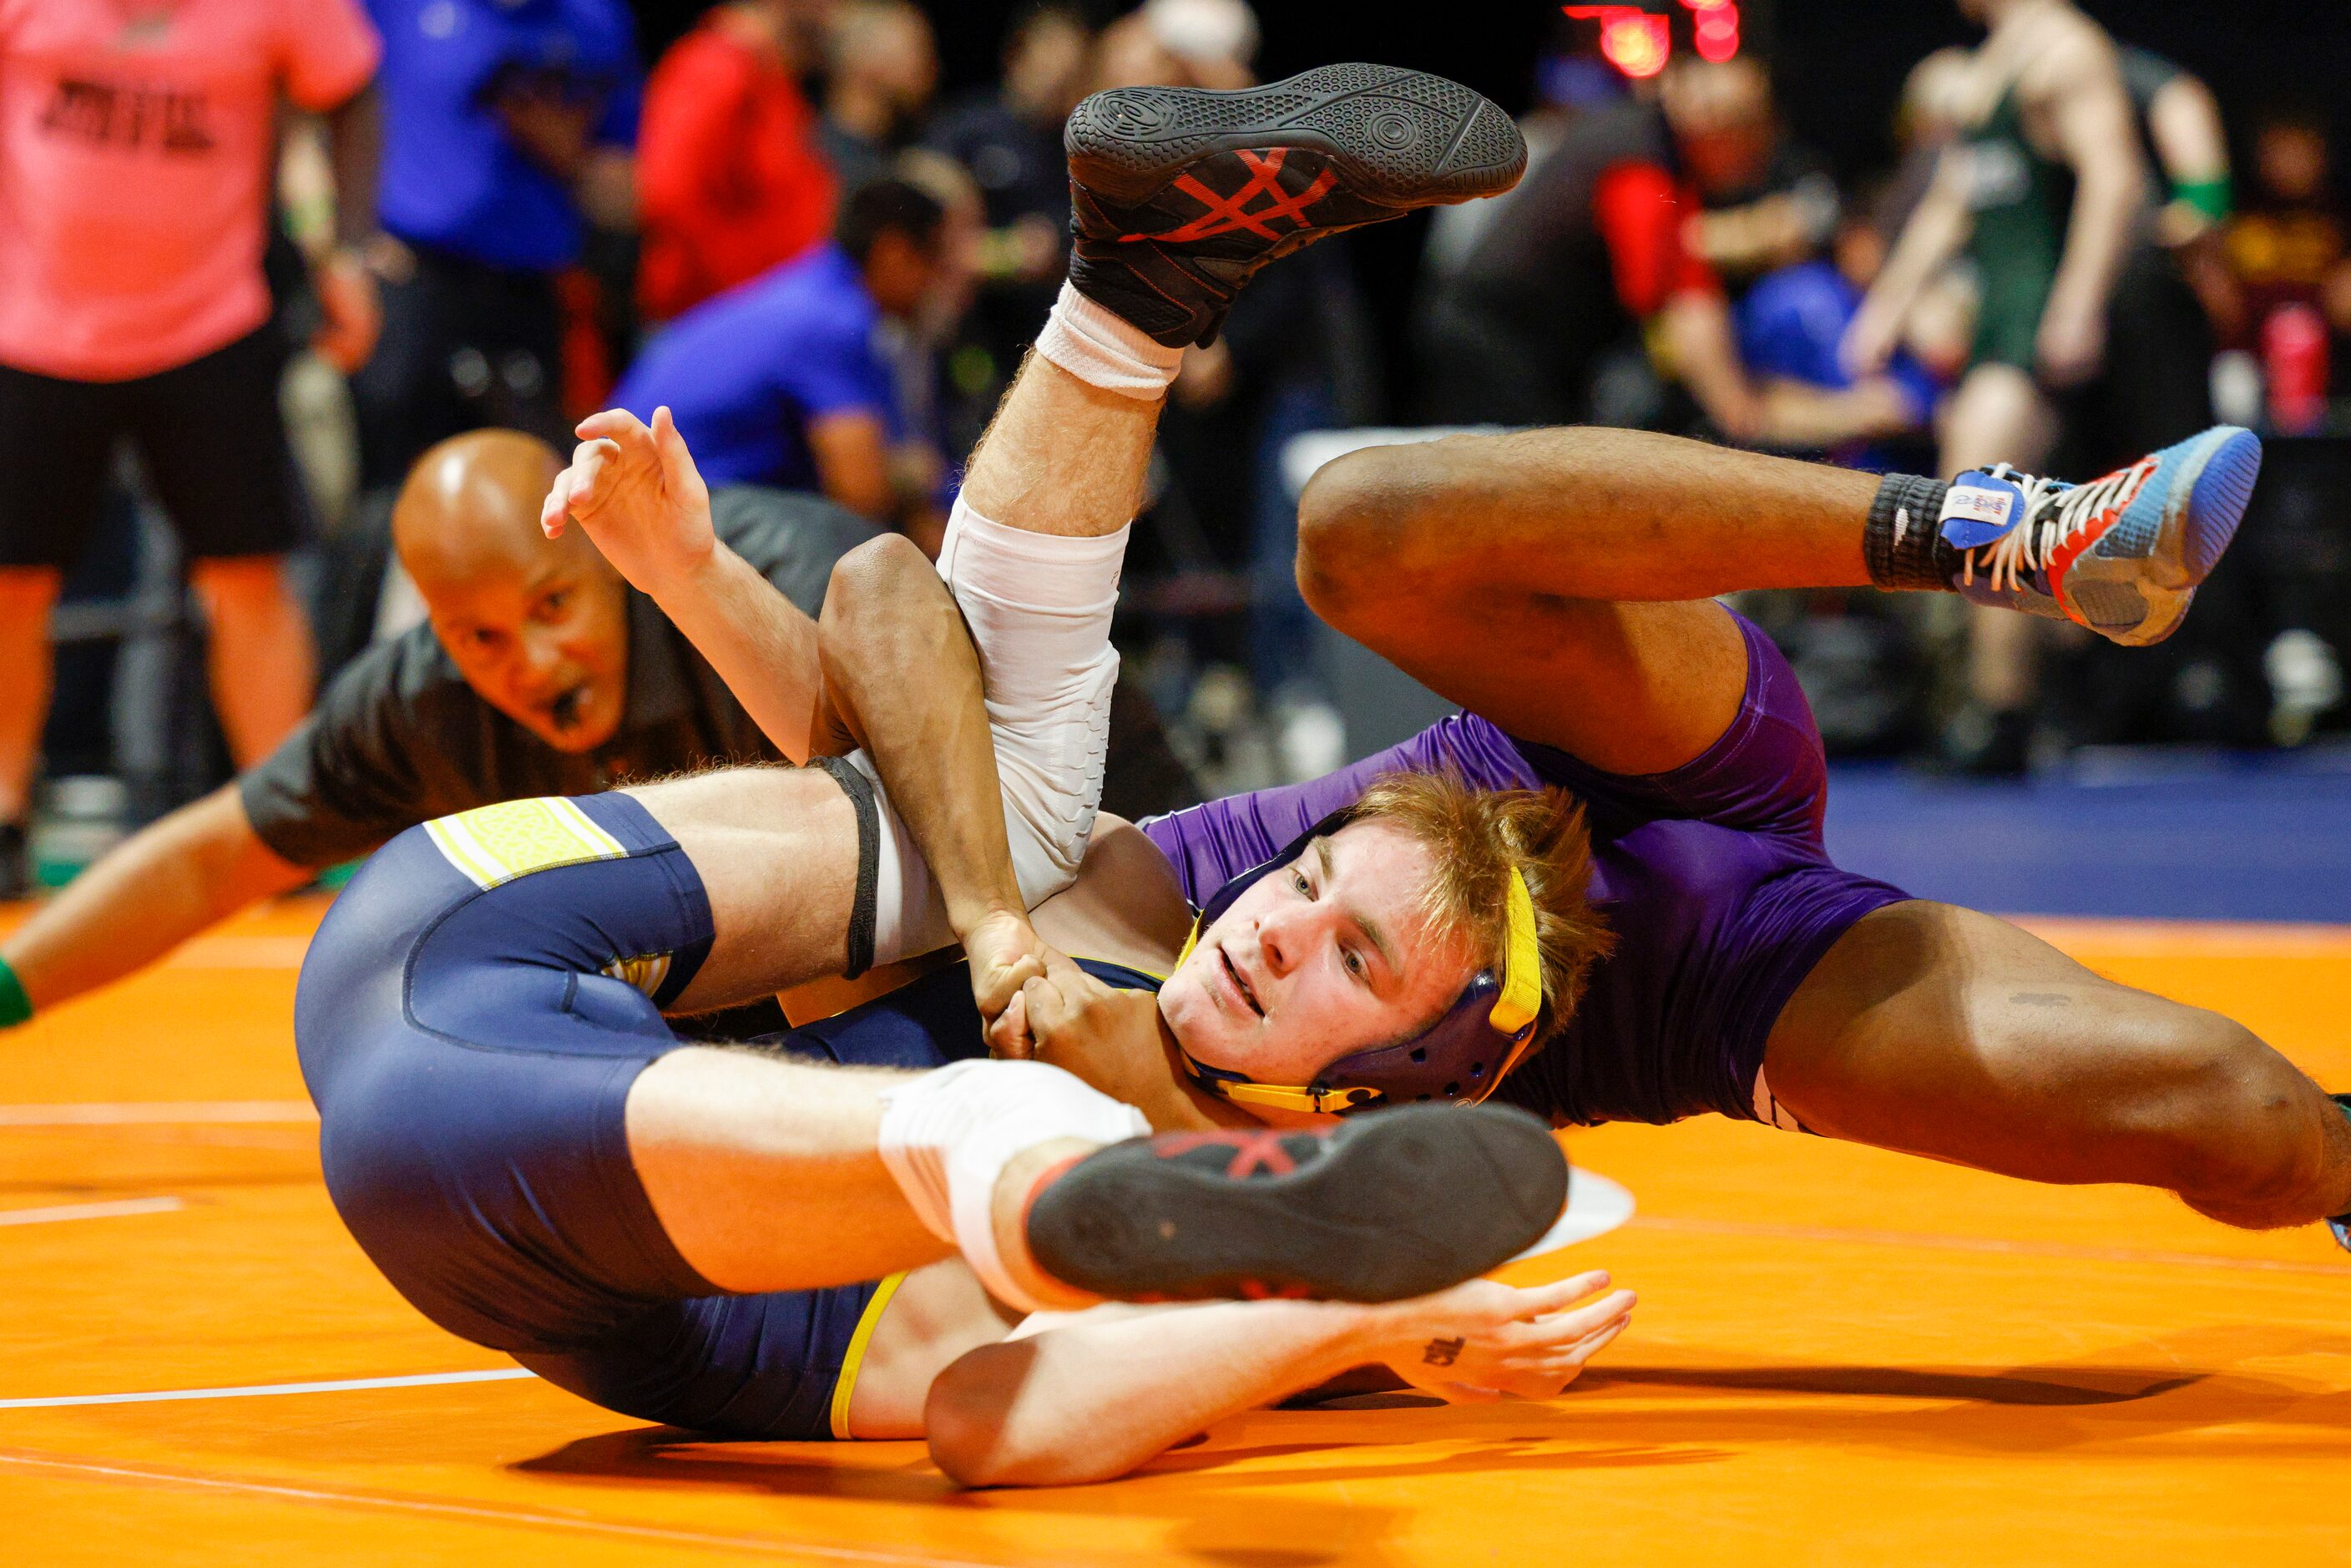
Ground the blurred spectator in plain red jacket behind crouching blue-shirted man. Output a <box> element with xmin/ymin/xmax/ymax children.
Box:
<box><xmin>637</xmin><ymin>0</ymin><xmax>837</xmax><ymax>322</ymax></box>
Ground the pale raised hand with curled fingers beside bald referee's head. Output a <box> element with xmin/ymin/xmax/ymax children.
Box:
<box><xmin>538</xmin><ymin>407</ymin><xmax>717</xmax><ymax>597</ymax></box>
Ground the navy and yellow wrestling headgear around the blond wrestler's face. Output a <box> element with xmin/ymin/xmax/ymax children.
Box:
<box><xmin>1176</xmin><ymin>813</ymin><xmax>1542</xmax><ymax>1116</ymax></box>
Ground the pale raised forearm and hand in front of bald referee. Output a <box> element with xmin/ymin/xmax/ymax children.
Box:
<box><xmin>538</xmin><ymin>409</ymin><xmax>823</xmax><ymax>761</ymax></box>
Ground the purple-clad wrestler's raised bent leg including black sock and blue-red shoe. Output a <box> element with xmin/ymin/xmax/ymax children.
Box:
<box><xmin>1297</xmin><ymin>413</ymin><xmax>2259</xmax><ymax>773</ymax></box>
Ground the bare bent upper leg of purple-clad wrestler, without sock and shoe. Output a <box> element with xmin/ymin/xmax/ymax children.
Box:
<box><xmin>1297</xmin><ymin>427</ymin><xmax>1878</xmax><ymax>773</ymax></box>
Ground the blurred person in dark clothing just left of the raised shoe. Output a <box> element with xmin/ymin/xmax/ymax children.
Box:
<box><xmin>927</xmin><ymin>5</ymin><xmax>1093</xmax><ymax>407</ymax></box>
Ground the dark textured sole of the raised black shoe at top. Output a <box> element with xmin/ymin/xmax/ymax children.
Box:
<box><xmin>1063</xmin><ymin>63</ymin><xmax>1526</xmax><ymax>211</ymax></box>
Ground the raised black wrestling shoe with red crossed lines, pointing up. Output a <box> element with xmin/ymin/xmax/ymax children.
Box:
<box><xmin>1063</xmin><ymin>66</ymin><xmax>1526</xmax><ymax>348</ymax></box>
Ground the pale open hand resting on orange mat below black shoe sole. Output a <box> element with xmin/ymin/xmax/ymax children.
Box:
<box><xmin>1380</xmin><ymin>1272</ymin><xmax>1636</xmax><ymax>1404</ymax></box>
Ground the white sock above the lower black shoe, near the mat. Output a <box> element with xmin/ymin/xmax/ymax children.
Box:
<box><xmin>882</xmin><ymin>1060</ymin><xmax>1152</xmax><ymax>1312</ymax></box>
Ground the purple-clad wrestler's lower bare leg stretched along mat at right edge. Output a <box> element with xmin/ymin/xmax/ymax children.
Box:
<box><xmin>1763</xmin><ymin>903</ymin><xmax>2351</xmax><ymax>1230</ymax></box>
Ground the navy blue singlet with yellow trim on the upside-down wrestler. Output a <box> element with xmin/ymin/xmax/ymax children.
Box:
<box><xmin>294</xmin><ymin>795</ymin><xmax>1147</xmax><ymax>1439</ymax></box>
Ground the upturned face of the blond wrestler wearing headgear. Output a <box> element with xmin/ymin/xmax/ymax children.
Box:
<box><xmin>1159</xmin><ymin>821</ymin><xmax>1476</xmax><ymax>1100</ymax></box>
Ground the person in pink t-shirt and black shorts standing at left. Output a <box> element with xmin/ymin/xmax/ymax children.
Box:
<box><xmin>0</xmin><ymin>0</ymin><xmax>378</xmax><ymax>898</ymax></box>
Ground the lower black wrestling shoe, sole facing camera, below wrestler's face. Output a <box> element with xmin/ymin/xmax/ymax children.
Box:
<box><xmin>1028</xmin><ymin>1105</ymin><xmax>1568</xmax><ymax>1302</ymax></box>
